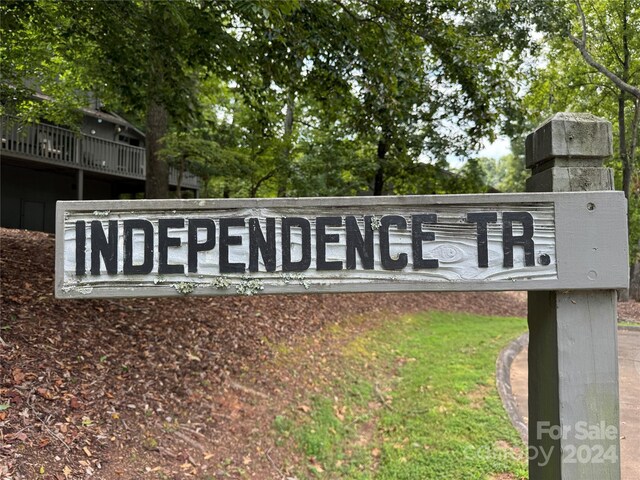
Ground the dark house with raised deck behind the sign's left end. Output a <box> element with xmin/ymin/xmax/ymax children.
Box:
<box><xmin>0</xmin><ymin>108</ymin><xmax>200</xmax><ymax>236</ymax></box>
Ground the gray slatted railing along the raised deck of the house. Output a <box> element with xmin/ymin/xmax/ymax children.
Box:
<box><xmin>0</xmin><ymin>116</ymin><xmax>200</xmax><ymax>188</ymax></box>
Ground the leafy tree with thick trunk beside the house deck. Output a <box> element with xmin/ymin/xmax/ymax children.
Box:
<box><xmin>2</xmin><ymin>0</ymin><xmax>236</xmax><ymax>198</ymax></box>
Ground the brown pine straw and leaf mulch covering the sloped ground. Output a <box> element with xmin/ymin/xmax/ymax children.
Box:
<box><xmin>0</xmin><ymin>229</ymin><xmax>640</xmax><ymax>480</ymax></box>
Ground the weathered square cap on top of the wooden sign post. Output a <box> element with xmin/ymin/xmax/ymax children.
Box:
<box><xmin>526</xmin><ymin>112</ymin><xmax>613</xmax><ymax>168</ymax></box>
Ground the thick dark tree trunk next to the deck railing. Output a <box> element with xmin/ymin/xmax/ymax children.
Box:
<box><xmin>145</xmin><ymin>100</ymin><xmax>169</xmax><ymax>198</ymax></box>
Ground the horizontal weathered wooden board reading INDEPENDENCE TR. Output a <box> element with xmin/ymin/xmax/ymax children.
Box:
<box><xmin>56</xmin><ymin>192</ymin><xmax>627</xmax><ymax>298</ymax></box>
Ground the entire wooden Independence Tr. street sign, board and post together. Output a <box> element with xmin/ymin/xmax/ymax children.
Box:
<box><xmin>56</xmin><ymin>111</ymin><xmax>628</xmax><ymax>480</ymax></box>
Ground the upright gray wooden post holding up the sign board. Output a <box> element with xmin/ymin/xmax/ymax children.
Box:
<box><xmin>527</xmin><ymin>113</ymin><xmax>629</xmax><ymax>480</ymax></box>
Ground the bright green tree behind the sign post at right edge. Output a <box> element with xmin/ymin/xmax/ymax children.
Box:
<box><xmin>526</xmin><ymin>0</ymin><xmax>640</xmax><ymax>299</ymax></box>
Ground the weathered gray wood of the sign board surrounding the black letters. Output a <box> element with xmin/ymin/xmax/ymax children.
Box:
<box><xmin>56</xmin><ymin>192</ymin><xmax>626</xmax><ymax>297</ymax></box>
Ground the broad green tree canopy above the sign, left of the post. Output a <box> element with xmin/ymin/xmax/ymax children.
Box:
<box><xmin>0</xmin><ymin>0</ymin><xmax>529</xmax><ymax>197</ymax></box>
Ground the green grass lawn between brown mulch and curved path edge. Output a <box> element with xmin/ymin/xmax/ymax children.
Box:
<box><xmin>274</xmin><ymin>312</ymin><xmax>527</xmax><ymax>480</ymax></box>
